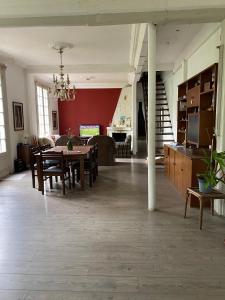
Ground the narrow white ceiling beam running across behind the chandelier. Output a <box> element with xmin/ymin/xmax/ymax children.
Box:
<box><xmin>26</xmin><ymin>64</ymin><xmax>134</xmax><ymax>74</ymax></box>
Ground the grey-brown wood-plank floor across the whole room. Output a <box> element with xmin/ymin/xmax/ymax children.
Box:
<box><xmin>0</xmin><ymin>160</ymin><xmax>225</xmax><ymax>300</ymax></box>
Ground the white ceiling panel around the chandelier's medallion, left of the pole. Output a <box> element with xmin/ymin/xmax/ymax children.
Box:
<box><xmin>0</xmin><ymin>25</ymin><xmax>131</xmax><ymax>66</ymax></box>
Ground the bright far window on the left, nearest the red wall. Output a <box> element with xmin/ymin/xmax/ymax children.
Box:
<box><xmin>37</xmin><ymin>85</ymin><xmax>50</xmax><ymax>136</ymax></box>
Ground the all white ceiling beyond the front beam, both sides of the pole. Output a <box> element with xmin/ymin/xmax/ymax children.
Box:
<box><xmin>0</xmin><ymin>24</ymin><xmax>204</xmax><ymax>86</ymax></box>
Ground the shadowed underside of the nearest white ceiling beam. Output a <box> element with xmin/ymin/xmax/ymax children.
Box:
<box><xmin>0</xmin><ymin>8</ymin><xmax>225</xmax><ymax>27</ymax></box>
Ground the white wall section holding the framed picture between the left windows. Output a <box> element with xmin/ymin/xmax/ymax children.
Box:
<box><xmin>0</xmin><ymin>57</ymin><xmax>29</xmax><ymax>177</ymax></box>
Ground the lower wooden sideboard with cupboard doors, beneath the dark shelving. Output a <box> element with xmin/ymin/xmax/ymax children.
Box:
<box><xmin>164</xmin><ymin>145</ymin><xmax>209</xmax><ymax>207</ymax></box>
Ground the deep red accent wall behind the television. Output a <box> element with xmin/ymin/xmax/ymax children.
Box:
<box><xmin>58</xmin><ymin>88</ymin><xmax>121</xmax><ymax>135</ymax></box>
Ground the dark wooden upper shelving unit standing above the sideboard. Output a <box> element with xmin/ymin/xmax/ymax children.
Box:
<box><xmin>177</xmin><ymin>64</ymin><xmax>218</xmax><ymax>148</ymax></box>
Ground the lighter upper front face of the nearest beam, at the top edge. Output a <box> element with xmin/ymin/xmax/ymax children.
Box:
<box><xmin>0</xmin><ymin>0</ymin><xmax>225</xmax><ymax>18</ymax></box>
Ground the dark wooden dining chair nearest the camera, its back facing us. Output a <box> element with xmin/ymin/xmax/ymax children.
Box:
<box><xmin>40</xmin><ymin>151</ymin><xmax>71</xmax><ymax>195</ymax></box>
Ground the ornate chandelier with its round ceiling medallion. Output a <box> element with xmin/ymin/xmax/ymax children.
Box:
<box><xmin>51</xmin><ymin>42</ymin><xmax>76</xmax><ymax>101</ymax></box>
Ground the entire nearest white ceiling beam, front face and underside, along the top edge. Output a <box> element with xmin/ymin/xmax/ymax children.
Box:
<box><xmin>0</xmin><ymin>0</ymin><xmax>225</xmax><ymax>27</ymax></box>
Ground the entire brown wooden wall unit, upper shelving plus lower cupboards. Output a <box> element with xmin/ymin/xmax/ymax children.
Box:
<box><xmin>164</xmin><ymin>64</ymin><xmax>218</xmax><ymax>206</ymax></box>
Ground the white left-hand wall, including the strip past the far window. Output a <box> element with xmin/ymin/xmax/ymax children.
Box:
<box><xmin>0</xmin><ymin>66</ymin><xmax>58</xmax><ymax>178</ymax></box>
